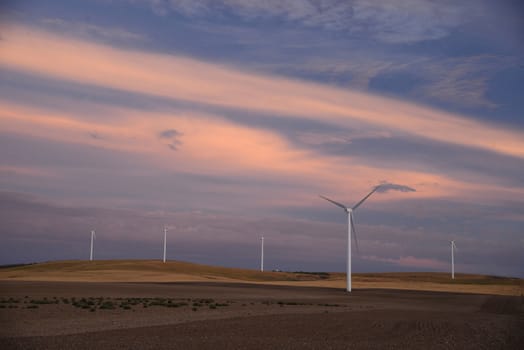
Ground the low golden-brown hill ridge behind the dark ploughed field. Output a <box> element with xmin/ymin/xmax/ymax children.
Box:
<box><xmin>0</xmin><ymin>260</ymin><xmax>524</xmax><ymax>295</ymax></box>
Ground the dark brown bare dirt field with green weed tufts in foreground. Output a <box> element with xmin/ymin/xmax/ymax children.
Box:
<box><xmin>0</xmin><ymin>281</ymin><xmax>524</xmax><ymax>350</ymax></box>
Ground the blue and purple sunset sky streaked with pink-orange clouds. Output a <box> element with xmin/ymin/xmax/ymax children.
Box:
<box><xmin>0</xmin><ymin>0</ymin><xmax>524</xmax><ymax>277</ymax></box>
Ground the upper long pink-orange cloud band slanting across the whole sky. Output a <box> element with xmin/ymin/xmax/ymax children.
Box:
<box><xmin>0</xmin><ymin>28</ymin><xmax>524</xmax><ymax>158</ymax></box>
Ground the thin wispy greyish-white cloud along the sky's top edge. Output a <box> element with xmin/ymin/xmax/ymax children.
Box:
<box><xmin>150</xmin><ymin>0</ymin><xmax>474</xmax><ymax>44</ymax></box>
